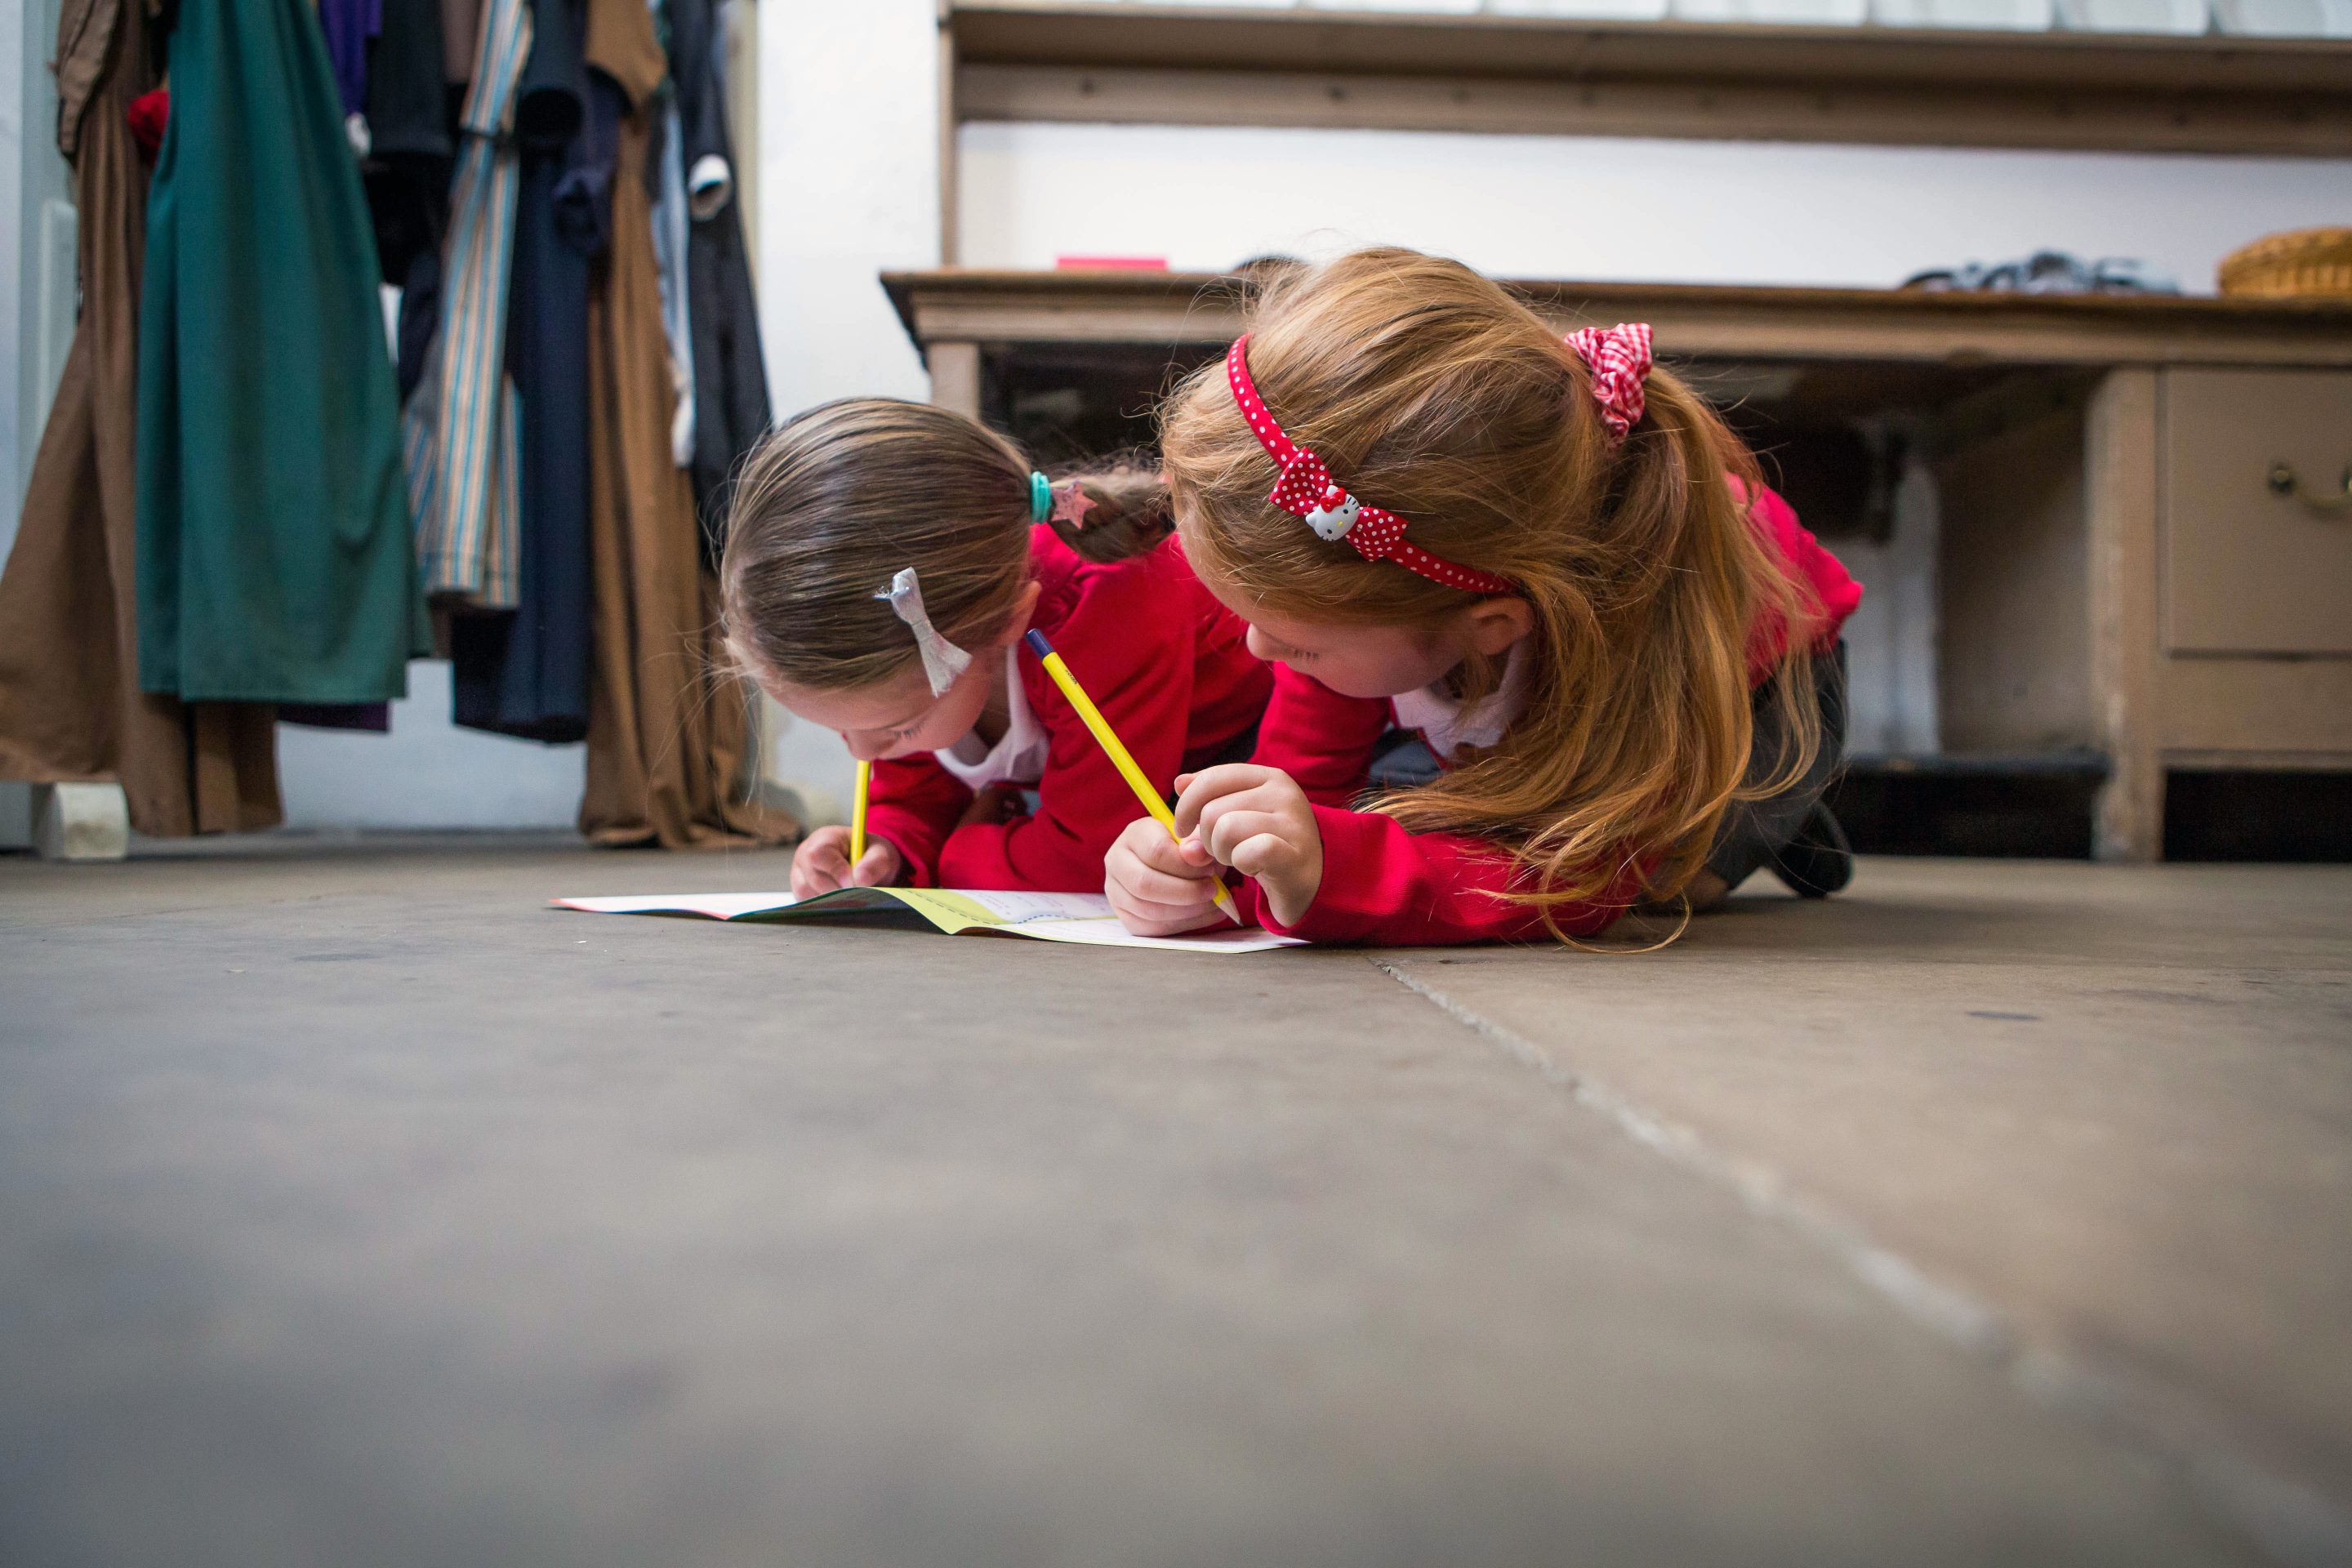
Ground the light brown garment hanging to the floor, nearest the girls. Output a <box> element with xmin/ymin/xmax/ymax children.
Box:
<box><xmin>581</xmin><ymin>0</ymin><xmax>797</xmax><ymax>849</ymax></box>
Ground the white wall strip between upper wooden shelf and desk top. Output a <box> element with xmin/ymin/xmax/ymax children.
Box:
<box><xmin>960</xmin><ymin>125</ymin><xmax>2352</xmax><ymax>292</ymax></box>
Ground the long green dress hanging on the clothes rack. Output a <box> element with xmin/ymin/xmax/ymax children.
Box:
<box><xmin>139</xmin><ymin>0</ymin><xmax>430</xmax><ymax>703</ymax></box>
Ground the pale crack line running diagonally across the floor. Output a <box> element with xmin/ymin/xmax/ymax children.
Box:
<box><xmin>1369</xmin><ymin>957</ymin><xmax>2352</xmax><ymax>1568</ymax></box>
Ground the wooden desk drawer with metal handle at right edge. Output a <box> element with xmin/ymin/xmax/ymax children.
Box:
<box><xmin>2162</xmin><ymin>369</ymin><xmax>2352</xmax><ymax>653</ymax></box>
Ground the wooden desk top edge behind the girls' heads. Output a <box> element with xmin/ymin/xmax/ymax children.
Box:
<box><xmin>882</xmin><ymin>268</ymin><xmax>2352</xmax><ymax>369</ymax></box>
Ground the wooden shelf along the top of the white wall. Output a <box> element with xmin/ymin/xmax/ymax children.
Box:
<box><xmin>941</xmin><ymin>0</ymin><xmax>2352</xmax><ymax>158</ymax></box>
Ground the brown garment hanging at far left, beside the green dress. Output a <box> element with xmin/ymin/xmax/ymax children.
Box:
<box><xmin>0</xmin><ymin>0</ymin><xmax>280</xmax><ymax>837</ymax></box>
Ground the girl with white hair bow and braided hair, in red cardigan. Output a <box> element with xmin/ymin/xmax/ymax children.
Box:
<box><xmin>719</xmin><ymin>397</ymin><xmax>1272</xmax><ymax>898</ymax></box>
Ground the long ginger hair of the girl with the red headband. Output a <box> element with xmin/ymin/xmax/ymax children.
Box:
<box><xmin>1162</xmin><ymin>249</ymin><xmax>1820</xmax><ymax>936</ymax></box>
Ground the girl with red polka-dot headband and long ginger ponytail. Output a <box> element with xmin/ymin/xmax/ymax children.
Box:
<box><xmin>1106</xmin><ymin>249</ymin><xmax>1860</xmax><ymax>942</ymax></box>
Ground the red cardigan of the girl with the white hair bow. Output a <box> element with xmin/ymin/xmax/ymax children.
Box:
<box><xmin>866</xmin><ymin>524</ymin><xmax>1272</xmax><ymax>893</ymax></box>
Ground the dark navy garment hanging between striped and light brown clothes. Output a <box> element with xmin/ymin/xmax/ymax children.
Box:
<box><xmin>449</xmin><ymin>0</ymin><xmax>597</xmax><ymax>741</ymax></box>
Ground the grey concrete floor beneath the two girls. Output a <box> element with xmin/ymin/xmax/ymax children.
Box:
<box><xmin>0</xmin><ymin>842</ymin><xmax>2352</xmax><ymax>1568</ymax></box>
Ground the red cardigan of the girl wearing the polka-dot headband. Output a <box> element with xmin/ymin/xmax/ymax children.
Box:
<box><xmin>1242</xmin><ymin>489</ymin><xmax>1863</xmax><ymax>947</ymax></box>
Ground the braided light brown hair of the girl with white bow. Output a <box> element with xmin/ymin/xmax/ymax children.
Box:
<box><xmin>719</xmin><ymin>397</ymin><xmax>1174</xmax><ymax>691</ymax></box>
